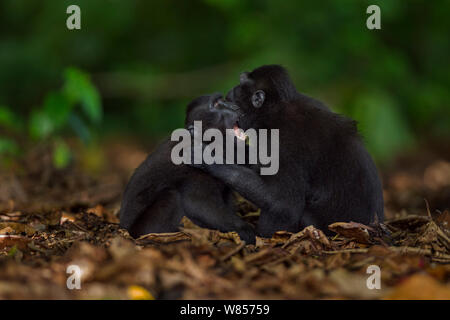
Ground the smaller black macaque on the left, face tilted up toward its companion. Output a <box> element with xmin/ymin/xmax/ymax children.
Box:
<box><xmin>120</xmin><ymin>94</ymin><xmax>255</xmax><ymax>244</ymax></box>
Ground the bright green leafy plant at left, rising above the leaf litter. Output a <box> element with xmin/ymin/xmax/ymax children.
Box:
<box><xmin>0</xmin><ymin>68</ymin><xmax>103</xmax><ymax>169</ymax></box>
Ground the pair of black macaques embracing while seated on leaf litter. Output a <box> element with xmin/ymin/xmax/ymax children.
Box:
<box><xmin>120</xmin><ymin>65</ymin><xmax>384</xmax><ymax>244</ymax></box>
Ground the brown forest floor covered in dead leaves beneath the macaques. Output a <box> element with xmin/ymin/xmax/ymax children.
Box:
<box><xmin>0</xmin><ymin>142</ymin><xmax>450</xmax><ymax>299</ymax></box>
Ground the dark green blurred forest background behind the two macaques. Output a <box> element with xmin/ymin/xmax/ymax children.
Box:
<box><xmin>0</xmin><ymin>0</ymin><xmax>450</xmax><ymax>161</ymax></box>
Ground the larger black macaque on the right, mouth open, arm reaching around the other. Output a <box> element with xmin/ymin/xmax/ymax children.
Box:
<box><xmin>188</xmin><ymin>65</ymin><xmax>384</xmax><ymax>237</ymax></box>
